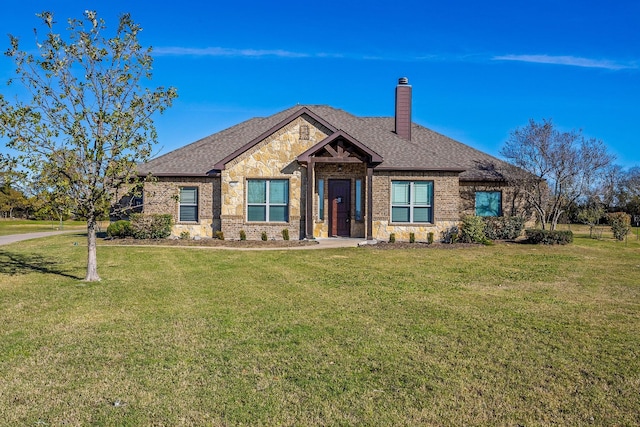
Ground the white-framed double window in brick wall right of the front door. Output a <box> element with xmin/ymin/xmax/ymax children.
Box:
<box><xmin>391</xmin><ymin>181</ymin><xmax>433</xmax><ymax>223</ymax></box>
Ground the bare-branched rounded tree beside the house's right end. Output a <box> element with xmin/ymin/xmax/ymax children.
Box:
<box><xmin>501</xmin><ymin>120</ymin><xmax>613</xmax><ymax>230</ymax></box>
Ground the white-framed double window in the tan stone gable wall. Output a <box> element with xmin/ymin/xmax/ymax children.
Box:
<box><xmin>247</xmin><ymin>179</ymin><xmax>289</xmax><ymax>222</ymax></box>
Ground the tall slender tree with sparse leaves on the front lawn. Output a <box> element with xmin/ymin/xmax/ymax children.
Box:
<box><xmin>0</xmin><ymin>11</ymin><xmax>177</xmax><ymax>281</ymax></box>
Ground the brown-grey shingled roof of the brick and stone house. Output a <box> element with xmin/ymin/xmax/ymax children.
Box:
<box><xmin>138</xmin><ymin>105</ymin><xmax>505</xmax><ymax>181</ymax></box>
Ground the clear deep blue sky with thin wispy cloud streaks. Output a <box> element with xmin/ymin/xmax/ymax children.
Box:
<box><xmin>0</xmin><ymin>0</ymin><xmax>640</xmax><ymax>167</ymax></box>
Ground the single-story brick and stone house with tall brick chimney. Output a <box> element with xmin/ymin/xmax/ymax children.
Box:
<box><xmin>139</xmin><ymin>78</ymin><xmax>515</xmax><ymax>240</ymax></box>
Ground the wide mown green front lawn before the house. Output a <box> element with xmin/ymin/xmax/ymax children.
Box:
<box><xmin>0</xmin><ymin>226</ymin><xmax>640</xmax><ymax>426</ymax></box>
